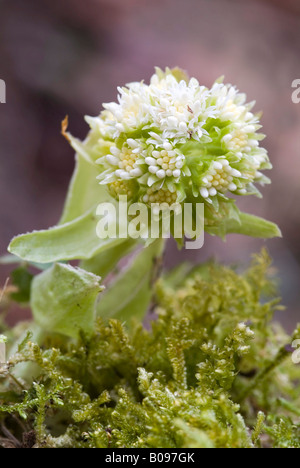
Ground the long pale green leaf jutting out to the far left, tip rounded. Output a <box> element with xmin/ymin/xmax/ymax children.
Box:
<box><xmin>8</xmin><ymin>207</ymin><xmax>123</xmax><ymax>263</ymax></box>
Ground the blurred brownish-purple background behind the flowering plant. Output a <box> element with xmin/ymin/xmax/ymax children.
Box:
<box><xmin>0</xmin><ymin>0</ymin><xmax>300</xmax><ymax>329</ymax></box>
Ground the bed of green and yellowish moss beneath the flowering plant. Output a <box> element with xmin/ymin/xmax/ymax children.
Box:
<box><xmin>0</xmin><ymin>252</ymin><xmax>300</xmax><ymax>448</ymax></box>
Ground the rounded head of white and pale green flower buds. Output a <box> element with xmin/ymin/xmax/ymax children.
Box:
<box><xmin>87</xmin><ymin>69</ymin><xmax>271</xmax><ymax>212</ymax></box>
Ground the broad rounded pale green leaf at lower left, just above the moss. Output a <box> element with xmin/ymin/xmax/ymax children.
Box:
<box><xmin>31</xmin><ymin>264</ymin><xmax>103</xmax><ymax>338</ymax></box>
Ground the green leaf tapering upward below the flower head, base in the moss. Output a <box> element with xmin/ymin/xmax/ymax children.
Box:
<box><xmin>98</xmin><ymin>240</ymin><xmax>164</xmax><ymax>321</ymax></box>
